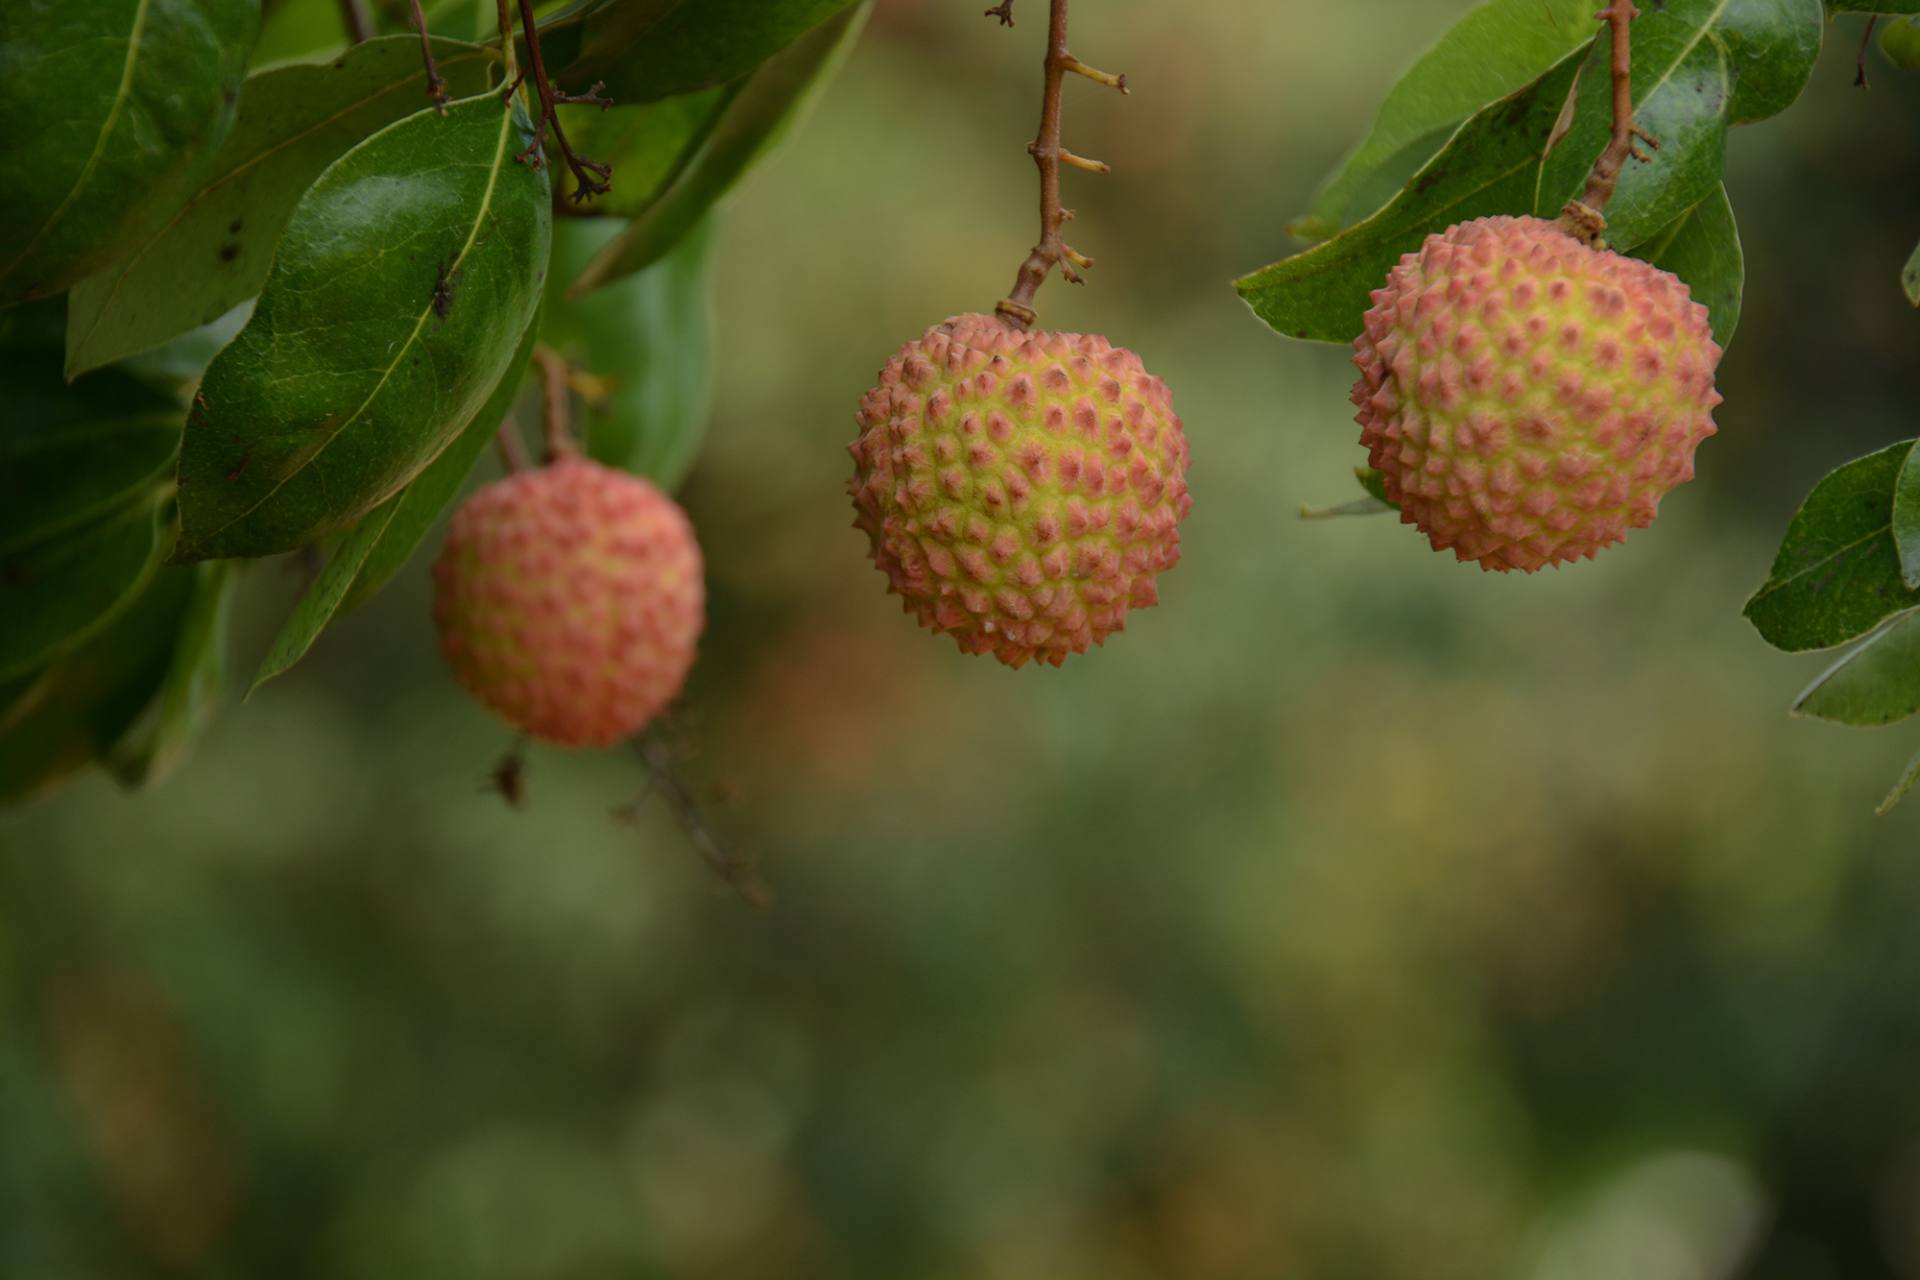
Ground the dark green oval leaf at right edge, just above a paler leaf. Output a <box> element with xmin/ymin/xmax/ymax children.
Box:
<box><xmin>1745</xmin><ymin>439</ymin><xmax>1920</xmax><ymax>652</ymax></box>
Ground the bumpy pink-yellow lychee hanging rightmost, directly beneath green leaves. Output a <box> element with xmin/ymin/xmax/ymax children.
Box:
<box><xmin>1354</xmin><ymin>217</ymin><xmax>1720</xmax><ymax>572</ymax></box>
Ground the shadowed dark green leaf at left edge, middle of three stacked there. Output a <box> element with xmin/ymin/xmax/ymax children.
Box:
<box><xmin>0</xmin><ymin>501</ymin><xmax>169</xmax><ymax>681</ymax></box>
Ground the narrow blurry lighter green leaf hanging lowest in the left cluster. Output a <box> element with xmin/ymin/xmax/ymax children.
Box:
<box><xmin>104</xmin><ymin>560</ymin><xmax>236</xmax><ymax>787</ymax></box>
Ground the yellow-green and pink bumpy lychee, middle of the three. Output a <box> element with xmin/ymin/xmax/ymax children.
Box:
<box><xmin>847</xmin><ymin>315</ymin><xmax>1192</xmax><ymax>668</ymax></box>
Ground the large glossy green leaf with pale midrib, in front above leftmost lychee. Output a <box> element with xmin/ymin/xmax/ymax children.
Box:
<box><xmin>179</xmin><ymin>92</ymin><xmax>551</xmax><ymax>560</ymax></box>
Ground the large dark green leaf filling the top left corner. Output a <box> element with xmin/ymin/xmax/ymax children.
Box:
<box><xmin>0</xmin><ymin>0</ymin><xmax>259</xmax><ymax>305</ymax></box>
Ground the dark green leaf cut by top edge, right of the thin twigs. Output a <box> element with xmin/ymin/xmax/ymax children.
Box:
<box><xmin>541</xmin><ymin>0</ymin><xmax>851</xmax><ymax>104</ymax></box>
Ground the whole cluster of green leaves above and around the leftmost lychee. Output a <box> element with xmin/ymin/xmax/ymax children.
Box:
<box><xmin>0</xmin><ymin>0</ymin><xmax>872</xmax><ymax>800</ymax></box>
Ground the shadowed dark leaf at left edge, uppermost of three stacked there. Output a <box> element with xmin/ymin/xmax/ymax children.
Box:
<box><xmin>0</xmin><ymin>413</ymin><xmax>180</xmax><ymax>553</ymax></box>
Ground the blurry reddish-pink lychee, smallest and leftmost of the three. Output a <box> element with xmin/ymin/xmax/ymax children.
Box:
<box><xmin>434</xmin><ymin>457</ymin><xmax>707</xmax><ymax>747</ymax></box>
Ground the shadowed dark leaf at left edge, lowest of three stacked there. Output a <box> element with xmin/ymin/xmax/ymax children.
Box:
<box><xmin>0</xmin><ymin>568</ymin><xmax>200</xmax><ymax>804</ymax></box>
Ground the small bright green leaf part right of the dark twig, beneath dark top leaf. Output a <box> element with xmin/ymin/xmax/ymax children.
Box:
<box><xmin>561</xmin><ymin>84</ymin><xmax>735</xmax><ymax>209</ymax></box>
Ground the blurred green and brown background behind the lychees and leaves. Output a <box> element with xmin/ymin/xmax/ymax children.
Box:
<box><xmin>0</xmin><ymin>0</ymin><xmax>1920</xmax><ymax>1280</ymax></box>
